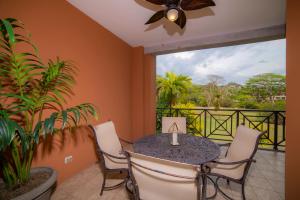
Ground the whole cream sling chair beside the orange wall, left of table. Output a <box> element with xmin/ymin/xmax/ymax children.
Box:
<box><xmin>89</xmin><ymin>121</ymin><xmax>129</xmax><ymax>195</ymax></box>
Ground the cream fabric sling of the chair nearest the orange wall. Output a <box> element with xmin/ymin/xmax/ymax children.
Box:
<box><xmin>92</xmin><ymin>121</ymin><xmax>127</xmax><ymax>169</ymax></box>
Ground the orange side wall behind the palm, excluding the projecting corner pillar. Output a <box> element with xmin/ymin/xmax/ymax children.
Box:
<box><xmin>0</xmin><ymin>0</ymin><xmax>132</xmax><ymax>181</ymax></box>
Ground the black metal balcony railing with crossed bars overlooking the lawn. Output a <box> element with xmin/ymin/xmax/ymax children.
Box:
<box><xmin>156</xmin><ymin>108</ymin><xmax>286</xmax><ymax>151</ymax></box>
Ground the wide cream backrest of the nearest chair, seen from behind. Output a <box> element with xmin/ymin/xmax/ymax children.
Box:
<box><xmin>127</xmin><ymin>152</ymin><xmax>199</xmax><ymax>200</ymax></box>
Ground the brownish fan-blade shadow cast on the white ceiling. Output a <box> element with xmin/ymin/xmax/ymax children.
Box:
<box><xmin>135</xmin><ymin>0</ymin><xmax>215</xmax><ymax>36</ymax></box>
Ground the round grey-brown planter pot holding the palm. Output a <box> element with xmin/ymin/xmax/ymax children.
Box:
<box><xmin>12</xmin><ymin>167</ymin><xmax>57</xmax><ymax>200</ymax></box>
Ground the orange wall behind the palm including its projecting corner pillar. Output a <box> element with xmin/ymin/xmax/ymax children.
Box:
<box><xmin>0</xmin><ymin>0</ymin><xmax>155</xmax><ymax>182</ymax></box>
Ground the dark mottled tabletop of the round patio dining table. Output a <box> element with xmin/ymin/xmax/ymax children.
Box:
<box><xmin>133</xmin><ymin>133</ymin><xmax>220</xmax><ymax>165</ymax></box>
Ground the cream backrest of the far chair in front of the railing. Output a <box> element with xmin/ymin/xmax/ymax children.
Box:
<box><xmin>161</xmin><ymin>117</ymin><xmax>186</xmax><ymax>133</ymax></box>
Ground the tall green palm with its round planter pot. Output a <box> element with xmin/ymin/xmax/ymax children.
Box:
<box><xmin>0</xmin><ymin>18</ymin><xmax>97</xmax><ymax>199</ymax></box>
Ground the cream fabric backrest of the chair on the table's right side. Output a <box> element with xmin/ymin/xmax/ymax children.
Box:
<box><xmin>226</xmin><ymin>125</ymin><xmax>263</xmax><ymax>161</ymax></box>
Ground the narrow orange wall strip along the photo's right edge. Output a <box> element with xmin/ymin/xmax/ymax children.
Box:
<box><xmin>286</xmin><ymin>0</ymin><xmax>300</xmax><ymax>200</ymax></box>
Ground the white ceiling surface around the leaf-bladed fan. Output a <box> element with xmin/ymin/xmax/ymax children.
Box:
<box><xmin>67</xmin><ymin>0</ymin><xmax>286</xmax><ymax>48</ymax></box>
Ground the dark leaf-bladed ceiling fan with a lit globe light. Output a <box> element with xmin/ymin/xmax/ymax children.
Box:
<box><xmin>145</xmin><ymin>0</ymin><xmax>216</xmax><ymax>29</ymax></box>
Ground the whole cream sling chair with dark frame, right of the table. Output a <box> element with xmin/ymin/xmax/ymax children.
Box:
<box><xmin>207</xmin><ymin>125</ymin><xmax>265</xmax><ymax>200</ymax></box>
